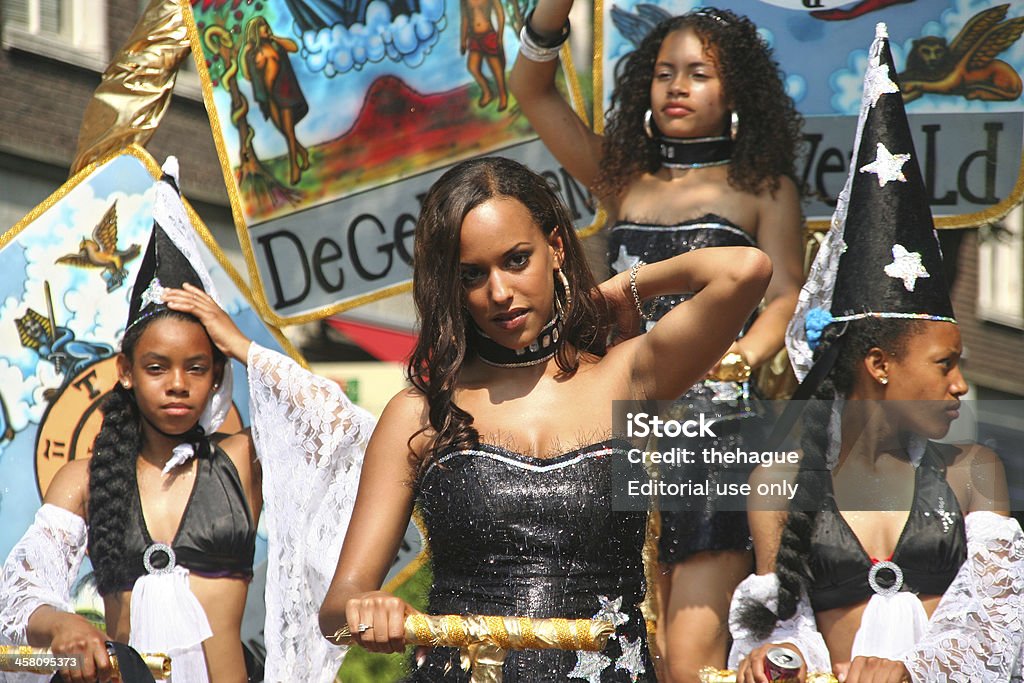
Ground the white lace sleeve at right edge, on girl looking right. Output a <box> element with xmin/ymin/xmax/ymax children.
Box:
<box><xmin>904</xmin><ymin>512</ymin><xmax>1024</xmax><ymax>683</ymax></box>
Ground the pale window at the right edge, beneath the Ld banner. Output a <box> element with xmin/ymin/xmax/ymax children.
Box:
<box><xmin>978</xmin><ymin>206</ymin><xmax>1024</xmax><ymax>330</ymax></box>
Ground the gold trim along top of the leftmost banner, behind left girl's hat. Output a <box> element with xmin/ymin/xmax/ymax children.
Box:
<box><xmin>0</xmin><ymin>144</ymin><xmax>299</xmax><ymax>368</ymax></box>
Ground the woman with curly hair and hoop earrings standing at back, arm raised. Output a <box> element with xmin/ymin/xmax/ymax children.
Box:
<box><xmin>510</xmin><ymin>0</ymin><xmax>802</xmax><ymax>683</ymax></box>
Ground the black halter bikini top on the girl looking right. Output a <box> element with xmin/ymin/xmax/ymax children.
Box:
<box><xmin>808</xmin><ymin>445</ymin><xmax>967</xmax><ymax>611</ymax></box>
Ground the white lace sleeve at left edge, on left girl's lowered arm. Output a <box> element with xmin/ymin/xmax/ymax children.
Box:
<box><xmin>0</xmin><ymin>504</ymin><xmax>85</xmax><ymax>645</ymax></box>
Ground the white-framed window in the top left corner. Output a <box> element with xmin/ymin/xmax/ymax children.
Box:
<box><xmin>0</xmin><ymin>0</ymin><xmax>106</xmax><ymax>71</ymax></box>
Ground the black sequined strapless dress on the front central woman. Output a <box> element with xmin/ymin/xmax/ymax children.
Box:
<box><xmin>410</xmin><ymin>439</ymin><xmax>655</xmax><ymax>683</ymax></box>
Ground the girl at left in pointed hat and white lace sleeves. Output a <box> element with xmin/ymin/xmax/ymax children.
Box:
<box><xmin>0</xmin><ymin>164</ymin><xmax>374</xmax><ymax>683</ymax></box>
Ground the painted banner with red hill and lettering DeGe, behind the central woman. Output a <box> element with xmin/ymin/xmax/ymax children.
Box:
<box><xmin>180</xmin><ymin>0</ymin><xmax>598</xmax><ymax>324</ymax></box>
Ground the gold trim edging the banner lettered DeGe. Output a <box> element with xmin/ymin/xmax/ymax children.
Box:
<box><xmin>177</xmin><ymin>0</ymin><xmax>606</xmax><ymax>327</ymax></box>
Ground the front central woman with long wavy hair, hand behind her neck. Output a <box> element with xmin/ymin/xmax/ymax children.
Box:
<box><xmin>321</xmin><ymin>158</ymin><xmax>771</xmax><ymax>683</ymax></box>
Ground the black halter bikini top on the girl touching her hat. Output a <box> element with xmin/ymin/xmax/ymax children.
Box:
<box><xmin>110</xmin><ymin>444</ymin><xmax>256</xmax><ymax>591</ymax></box>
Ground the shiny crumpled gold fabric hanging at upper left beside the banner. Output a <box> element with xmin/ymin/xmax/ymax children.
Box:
<box><xmin>71</xmin><ymin>0</ymin><xmax>189</xmax><ymax>175</ymax></box>
